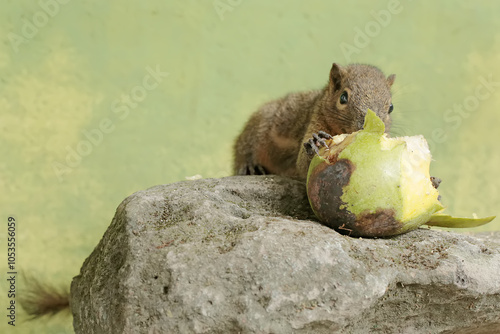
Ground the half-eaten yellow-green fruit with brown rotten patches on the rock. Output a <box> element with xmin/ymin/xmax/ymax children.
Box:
<box><xmin>307</xmin><ymin>110</ymin><xmax>494</xmax><ymax>237</ymax></box>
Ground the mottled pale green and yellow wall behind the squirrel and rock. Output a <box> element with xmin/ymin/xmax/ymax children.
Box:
<box><xmin>0</xmin><ymin>0</ymin><xmax>500</xmax><ymax>333</ymax></box>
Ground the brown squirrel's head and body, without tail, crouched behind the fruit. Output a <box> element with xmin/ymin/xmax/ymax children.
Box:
<box><xmin>233</xmin><ymin>63</ymin><xmax>396</xmax><ymax>180</ymax></box>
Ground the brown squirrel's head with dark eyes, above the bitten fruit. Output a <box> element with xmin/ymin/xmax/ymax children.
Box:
<box><xmin>326</xmin><ymin>63</ymin><xmax>396</xmax><ymax>133</ymax></box>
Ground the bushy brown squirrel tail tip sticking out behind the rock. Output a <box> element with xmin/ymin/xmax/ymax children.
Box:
<box><xmin>19</xmin><ymin>276</ymin><xmax>70</xmax><ymax>319</ymax></box>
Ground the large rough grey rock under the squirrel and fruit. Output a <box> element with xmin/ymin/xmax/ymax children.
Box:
<box><xmin>71</xmin><ymin>176</ymin><xmax>500</xmax><ymax>334</ymax></box>
